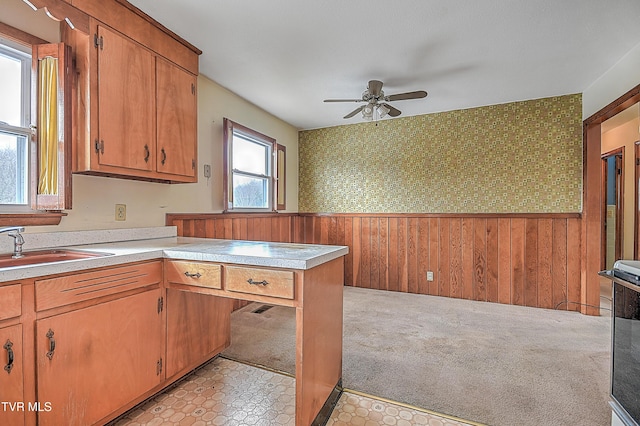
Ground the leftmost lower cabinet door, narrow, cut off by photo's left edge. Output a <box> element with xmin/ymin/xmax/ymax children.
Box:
<box><xmin>0</xmin><ymin>324</ymin><xmax>23</xmax><ymax>426</ymax></box>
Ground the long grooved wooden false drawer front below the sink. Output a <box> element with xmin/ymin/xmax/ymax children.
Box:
<box><xmin>35</xmin><ymin>261</ymin><xmax>162</xmax><ymax>311</ymax></box>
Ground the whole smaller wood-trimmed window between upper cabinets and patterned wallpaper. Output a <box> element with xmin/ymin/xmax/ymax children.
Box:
<box><xmin>224</xmin><ymin>118</ymin><xmax>276</xmax><ymax>211</ymax></box>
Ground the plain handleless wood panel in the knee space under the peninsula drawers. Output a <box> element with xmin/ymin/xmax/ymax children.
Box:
<box><xmin>167</xmin><ymin>288</ymin><xmax>232</xmax><ymax>378</ymax></box>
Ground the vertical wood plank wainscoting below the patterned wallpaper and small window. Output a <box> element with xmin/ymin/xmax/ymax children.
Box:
<box><xmin>167</xmin><ymin>213</ymin><xmax>583</xmax><ymax>311</ymax></box>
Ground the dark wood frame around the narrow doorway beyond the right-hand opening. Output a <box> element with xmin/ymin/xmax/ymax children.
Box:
<box><xmin>600</xmin><ymin>146</ymin><xmax>625</xmax><ymax>269</ymax></box>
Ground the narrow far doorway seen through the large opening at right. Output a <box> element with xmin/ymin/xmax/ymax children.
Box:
<box><xmin>602</xmin><ymin>147</ymin><xmax>624</xmax><ymax>269</ymax></box>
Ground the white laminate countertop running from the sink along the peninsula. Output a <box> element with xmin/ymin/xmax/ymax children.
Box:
<box><xmin>0</xmin><ymin>226</ymin><xmax>349</xmax><ymax>283</ymax></box>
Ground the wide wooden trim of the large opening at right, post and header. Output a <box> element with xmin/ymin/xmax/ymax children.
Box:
<box><xmin>580</xmin><ymin>85</ymin><xmax>640</xmax><ymax>315</ymax></box>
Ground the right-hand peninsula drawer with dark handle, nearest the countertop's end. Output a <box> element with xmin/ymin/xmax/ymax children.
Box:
<box><xmin>224</xmin><ymin>266</ymin><xmax>294</xmax><ymax>299</ymax></box>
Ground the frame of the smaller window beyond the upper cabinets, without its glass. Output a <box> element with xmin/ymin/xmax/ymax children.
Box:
<box><xmin>224</xmin><ymin>118</ymin><xmax>276</xmax><ymax>213</ymax></box>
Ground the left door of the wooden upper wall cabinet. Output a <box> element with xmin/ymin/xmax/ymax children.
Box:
<box><xmin>96</xmin><ymin>26</ymin><xmax>156</xmax><ymax>172</ymax></box>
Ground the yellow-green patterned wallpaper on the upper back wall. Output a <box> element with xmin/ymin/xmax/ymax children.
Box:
<box><xmin>299</xmin><ymin>94</ymin><xmax>582</xmax><ymax>213</ymax></box>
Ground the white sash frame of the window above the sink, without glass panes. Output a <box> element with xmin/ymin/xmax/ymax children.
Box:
<box><xmin>0</xmin><ymin>37</ymin><xmax>33</xmax><ymax>213</ymax></box>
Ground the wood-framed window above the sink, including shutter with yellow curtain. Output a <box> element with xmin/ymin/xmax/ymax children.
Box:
<box><xmin>0</xmin><ymin>22</ymin><xmax>73</xmax><ymax>221</ymax></box>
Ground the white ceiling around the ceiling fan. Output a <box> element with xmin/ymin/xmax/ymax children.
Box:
<box><xmin>130</xmin><ymin>0</ymin><xmax>640</xmax><ymax>129</ymax></box>
